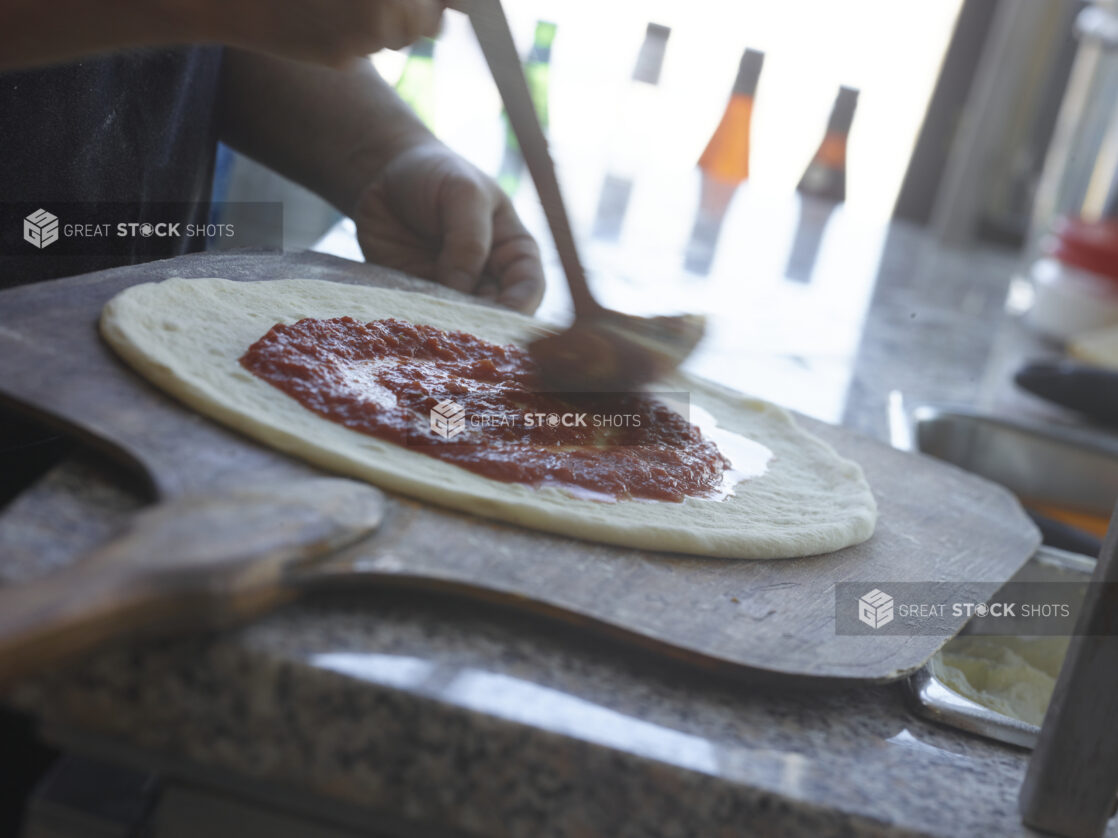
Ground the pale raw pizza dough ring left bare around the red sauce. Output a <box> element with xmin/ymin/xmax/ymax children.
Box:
<box><xmin>101</xmin><ymin>278</ymin><xmax>877</xmax><ymax>559</ymax></box>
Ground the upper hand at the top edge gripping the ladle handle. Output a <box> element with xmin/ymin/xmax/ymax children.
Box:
<box><xmin>162</xmin><ymin>0</ymin><xmax>445</xmax><ymax>67</ymax></box>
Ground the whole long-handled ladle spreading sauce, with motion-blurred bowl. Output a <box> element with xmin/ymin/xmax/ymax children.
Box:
<box><xmin>456</xmin><ymin>0</ymin><xmax>704</xmax><ymax>391</ymax></box>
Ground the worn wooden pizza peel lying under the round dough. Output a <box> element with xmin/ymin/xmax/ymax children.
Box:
<box><xmin>0</xmin><ymin>253</ymin><xmax>1040</xmax><ymax>685</ymax></box>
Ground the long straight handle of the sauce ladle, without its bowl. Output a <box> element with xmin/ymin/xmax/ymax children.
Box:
<box><xmin>467</xmin><ymin>0</ymin><xmax>601</xmax><ymax>317</ymax></box>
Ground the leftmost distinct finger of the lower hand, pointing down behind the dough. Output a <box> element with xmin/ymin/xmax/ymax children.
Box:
<box><xmin>436</xmin><ymin>177</ymin><xmax>493</xmax><ymax>294</ymax></box>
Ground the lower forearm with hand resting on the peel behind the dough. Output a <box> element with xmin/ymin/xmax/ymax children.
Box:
<box><xmin>220</xmin><ymin>50</ymin><xmax>543</xmax><ymax>311</ymax></box>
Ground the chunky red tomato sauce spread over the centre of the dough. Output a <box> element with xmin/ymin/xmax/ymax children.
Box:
<box><xmin>240</xmin><ymin>317</ymin><xmax>771</xmax><ymax>502</ymax></box>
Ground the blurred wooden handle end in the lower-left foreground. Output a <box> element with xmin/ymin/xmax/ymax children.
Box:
<box><xmin>0</xmin><ymin>478</ymin><xmax>383</xmax><ymax>689</ymax></box>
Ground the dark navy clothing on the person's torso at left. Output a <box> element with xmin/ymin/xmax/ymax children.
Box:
<box><xmin>0</xmin><ymin>47</ymin><xmax>221</xmax><ymax>287</ymax></box>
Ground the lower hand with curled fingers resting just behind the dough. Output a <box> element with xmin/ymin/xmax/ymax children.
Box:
<box><xmin>353</xmin><ymin>141</ymin><xmax>543</xmax><ymax>313</ymax></box>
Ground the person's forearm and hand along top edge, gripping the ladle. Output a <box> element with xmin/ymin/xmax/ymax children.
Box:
<box><xmin>0</xmin><ymin>0</ymin><xmax>443</xmax><ymax>70</ymax></box>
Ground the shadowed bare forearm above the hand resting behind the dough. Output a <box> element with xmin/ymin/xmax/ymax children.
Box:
<box><xmin>220</xmin><ymin>49</ymin><xmax>435</xmax><ymax>215</ymax></box>
